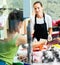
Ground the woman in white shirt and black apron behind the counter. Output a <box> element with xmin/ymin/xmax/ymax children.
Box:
<box><xmin>31</xmin><ymin>1</ymin><xmax>52</xmax><ymax>41</ymax></box>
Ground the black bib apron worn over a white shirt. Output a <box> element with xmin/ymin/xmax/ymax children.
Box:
<box><xmin>33</xmin><ymin>14</ymin><xmax>48</xmax><ymax>41</ymax></box>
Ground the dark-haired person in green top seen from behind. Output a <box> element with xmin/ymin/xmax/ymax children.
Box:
<box><xmin>0</xmin><ymin>10</ymin><xmax>27</xmax><ymax>65</ymax></box>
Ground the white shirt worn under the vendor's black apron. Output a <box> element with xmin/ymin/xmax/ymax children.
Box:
<box><xmin>30</xmin><ymin>14</ymin><xmax>52</xmax><ymax>32</ymax></box>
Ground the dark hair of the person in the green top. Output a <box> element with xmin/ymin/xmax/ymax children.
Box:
<box><xmin>8</xmin><ymin>10</ymin><xmax>23</xmax><ymax>33</ymax></box>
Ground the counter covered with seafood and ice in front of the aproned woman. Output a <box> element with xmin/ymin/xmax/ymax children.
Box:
<box><xmin>14</xmin><ymin>38</ymin><xmax>60</xmax><ymax>65</ymax></box>
